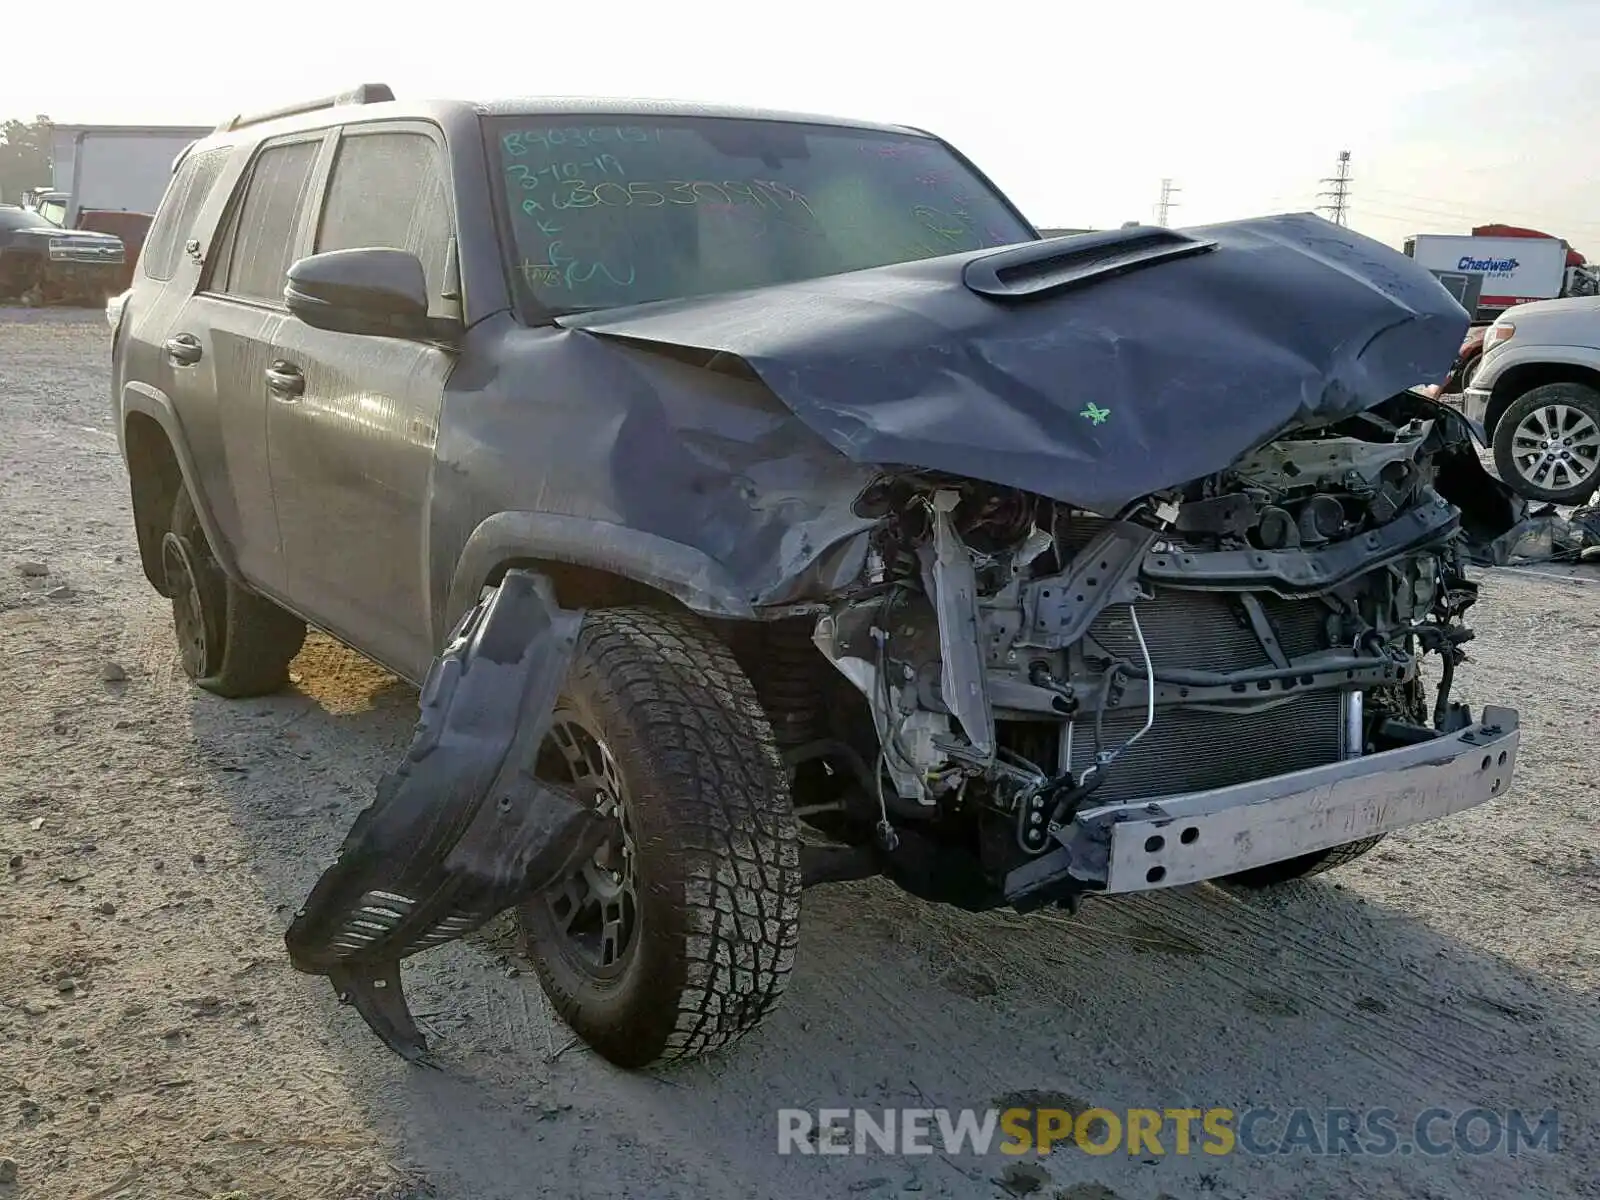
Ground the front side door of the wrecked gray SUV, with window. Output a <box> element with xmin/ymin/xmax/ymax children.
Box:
<box><xmin>267</xmin><ymin>122</ymin><xmax>459</xmax><ymax>678</ymax></box>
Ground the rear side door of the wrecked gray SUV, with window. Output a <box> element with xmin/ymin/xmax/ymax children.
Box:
<box><xmin>152</xmin><ymin>131</ymin><xmax>331</xmax><ymax>600</ymax></box>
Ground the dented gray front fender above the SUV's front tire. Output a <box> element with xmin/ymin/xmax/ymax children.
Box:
<box><xmin>429</xmin><ymin>317</ymin><xmax>874</xmax><ymax>649</ymax></box>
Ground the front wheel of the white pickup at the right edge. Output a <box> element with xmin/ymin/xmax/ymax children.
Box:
<box><xmin>1494</xmin><ymin>384</ymin><xmax>1600</xmax><ymax>504</ymax></box>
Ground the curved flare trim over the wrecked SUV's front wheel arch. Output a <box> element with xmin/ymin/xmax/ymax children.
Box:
<box><xmin>434</xmin><ymin>510</ymin><xmax>755</xmax><ymax>642</ymax></box>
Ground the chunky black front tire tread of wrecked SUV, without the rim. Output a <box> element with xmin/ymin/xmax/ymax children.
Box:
<box><xmin>518</xmin><ymin>608</ymin><xmax>800</xmax><ymax>1067</ymax></box>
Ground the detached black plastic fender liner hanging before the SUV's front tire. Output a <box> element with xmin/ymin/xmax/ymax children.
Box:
<box><xmin>285</xmin><ymin>570</ymin><xmax>606</xmax><ymax>1062</ymax></box>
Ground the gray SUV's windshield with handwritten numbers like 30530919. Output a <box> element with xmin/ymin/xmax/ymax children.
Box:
<box><xmin>490</xmin><ymin>115</ymin><xmax>1034</xmax><ymax>314</ymax></box>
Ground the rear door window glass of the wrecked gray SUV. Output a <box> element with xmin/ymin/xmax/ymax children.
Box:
<box><xmin>211</xmin><ymin>138</ymin><xmax>322</xmax><ymax>306</ymax></box>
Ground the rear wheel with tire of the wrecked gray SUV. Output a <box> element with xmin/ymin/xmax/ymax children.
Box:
<box><xmin>162</xmin><ymin>486</ymin><xmax>306</xmax><ymax>699</ymax></box>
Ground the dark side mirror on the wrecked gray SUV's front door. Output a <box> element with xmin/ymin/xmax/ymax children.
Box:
<box><xmin>283</xmin><ymin>246</ymin><xmax>454</xmax><ymax>338</ymax></box>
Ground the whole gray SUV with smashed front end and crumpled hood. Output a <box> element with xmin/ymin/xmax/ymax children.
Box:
<box><xmin>114</xmin><ymin>85</ymin><xmax>1518</xmax><ymax>1066</ymax></box>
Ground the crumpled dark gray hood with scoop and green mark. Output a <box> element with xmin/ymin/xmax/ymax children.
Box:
<box><xmin>560</xmin><ymin>214</ymin><xmax>1467</xmax><ymax>514</ymax></box>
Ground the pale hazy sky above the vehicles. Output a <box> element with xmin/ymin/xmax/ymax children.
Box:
<box><xmin>0</xmin><ymin>0</ymin><xmax>1600</xmax><ymax>258</ymax></box>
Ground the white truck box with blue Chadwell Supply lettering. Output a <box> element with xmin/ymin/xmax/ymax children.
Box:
<box><xmin>1405</xmin><ymin>234</ymin><xmax>1582</xmax><ymax>322</ymax></box>
